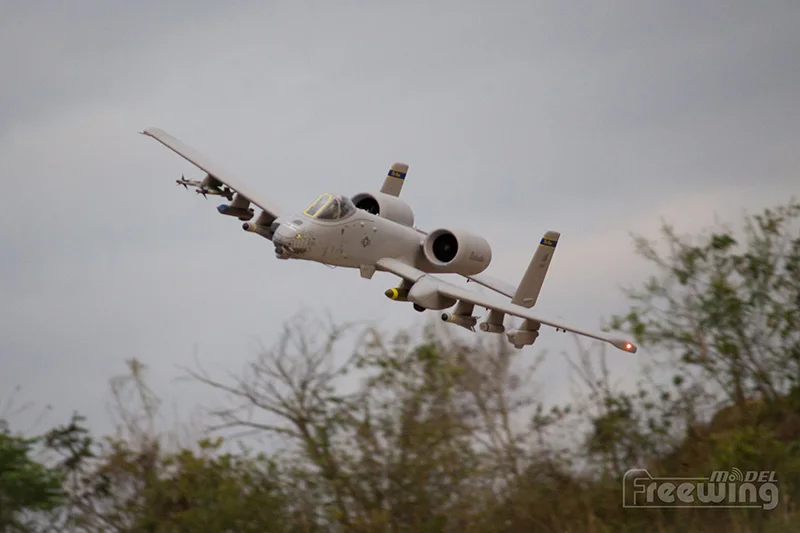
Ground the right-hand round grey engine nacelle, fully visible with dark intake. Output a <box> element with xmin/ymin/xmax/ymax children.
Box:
<box><xmin>422</xmin><ymin>229</ymin><xmax>492</xmax><ymax>276</ymax></box>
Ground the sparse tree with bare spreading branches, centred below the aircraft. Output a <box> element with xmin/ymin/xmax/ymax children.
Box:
<box><xmin>193</xmin><ymin>314</ymin><xmax>548</xmax><ymax>532</ymax></box>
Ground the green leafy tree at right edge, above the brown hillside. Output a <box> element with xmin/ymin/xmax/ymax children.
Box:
<box><xmin>613</xmin><ymin>202</ymin><xmax>800</xmax><ymax>411</ymax></box>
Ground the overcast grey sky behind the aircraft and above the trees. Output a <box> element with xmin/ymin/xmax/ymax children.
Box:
<box><xmin>0</xmin><ymin>0</ymin><xmax>800</xmax><ymax>436</ymax></box>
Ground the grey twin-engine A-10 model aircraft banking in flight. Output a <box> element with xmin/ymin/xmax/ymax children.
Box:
<box><xmin>141</xmin><ymin>128</ymin><xmax>636</xmax><ymax>353</ymax></box>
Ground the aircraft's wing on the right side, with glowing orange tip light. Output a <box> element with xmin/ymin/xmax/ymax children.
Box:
<box><xmin>377</xmin><ymin>258</ymin><xmax>637</xmax><ymax>353</ymax></box>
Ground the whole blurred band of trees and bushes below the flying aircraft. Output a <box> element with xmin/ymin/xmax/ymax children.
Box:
<box><xmin>0</xmin><ymin>198</ymin><xmax>800</xmax><ymax>533</ymax></box>
